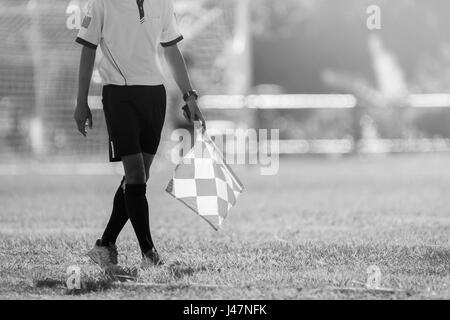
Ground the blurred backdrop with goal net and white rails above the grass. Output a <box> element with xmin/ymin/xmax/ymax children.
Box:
<box><xmin>0</xmin><ymin>0</ymin><xmax>450</xmax><ymax>168</ymax></box>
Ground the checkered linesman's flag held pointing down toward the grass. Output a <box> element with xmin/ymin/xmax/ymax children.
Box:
<box><xmin>166</xmin><ymin>122</ymin><xmax>243</xmax><ymax>231</ymax></box>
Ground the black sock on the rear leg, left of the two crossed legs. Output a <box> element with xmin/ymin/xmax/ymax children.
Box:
<box><xmin>101</xmin><ymin>178</ymin><xmax>128</xmax><ymax>246</ymax></box>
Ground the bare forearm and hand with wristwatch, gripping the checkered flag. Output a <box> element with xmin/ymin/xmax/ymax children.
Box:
<box><xmin>163</xmin><ymin>44</ymin><xmax>206</xmax><ymax>129</ymax></box>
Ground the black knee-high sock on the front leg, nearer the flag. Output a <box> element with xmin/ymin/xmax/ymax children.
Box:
<box><xmin>125</xmin><ymin>184</ymin><xmax>154</xmax><ymax>253</ymax></box>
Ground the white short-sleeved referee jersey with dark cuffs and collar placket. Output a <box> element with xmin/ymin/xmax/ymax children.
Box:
<box><xmin>76</xmin><ymin>0</ymin><xmax>183</xmax><ymax>85</ymax></box>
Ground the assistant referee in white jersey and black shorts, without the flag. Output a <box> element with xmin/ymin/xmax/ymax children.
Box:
<box><xmin>74</xmin><ymin>0</ymin><xmax>205</xmax><ymax>269</ymax></box>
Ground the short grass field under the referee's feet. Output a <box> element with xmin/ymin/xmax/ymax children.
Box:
<box><xmin>0</xmin><ymin>155</ymin><xmax>450</xmax><ymax>299</ymax></box>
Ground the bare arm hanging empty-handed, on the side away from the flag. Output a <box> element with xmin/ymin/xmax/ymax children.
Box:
<box><xmin>73</xmin><ymin>46</ymin><xmax>96</xmax><ymax>136</ymax></box>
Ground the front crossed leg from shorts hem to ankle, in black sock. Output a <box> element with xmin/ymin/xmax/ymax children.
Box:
<box><xmin>122</xmin><ymin>153</ymin><xmax>154</xmax><ymax>255</ymax></box>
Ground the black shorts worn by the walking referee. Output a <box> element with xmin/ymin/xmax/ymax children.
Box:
<box><xmin>102</xmin><ymin>85</ymin><xmax>166</xmax><ymax>162</ymax></box>
